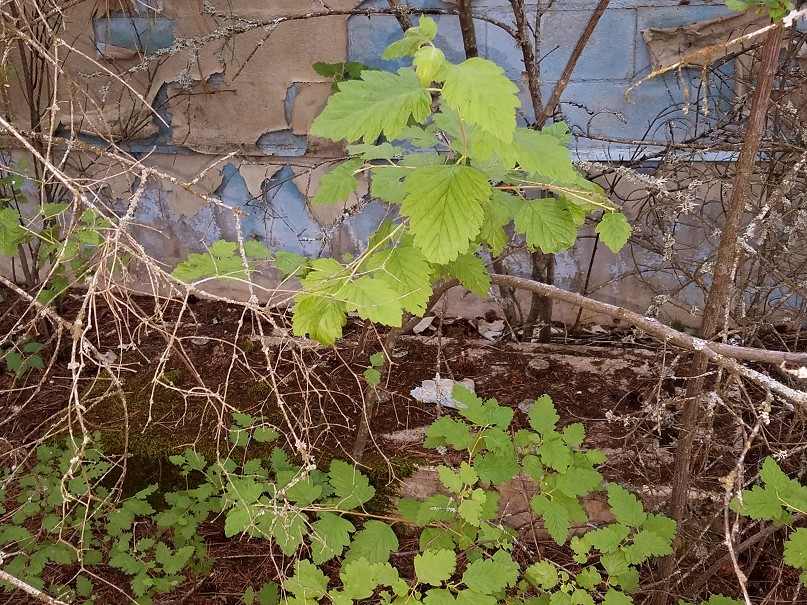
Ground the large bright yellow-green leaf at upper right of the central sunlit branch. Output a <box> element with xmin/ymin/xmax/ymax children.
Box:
<box><xmin>442</xmin><ymin>57</ymin><xmax>521</xmax><ymax>143</ymax></box>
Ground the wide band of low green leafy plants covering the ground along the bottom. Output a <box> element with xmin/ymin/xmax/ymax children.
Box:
<box><xmin>0</xmin><ymin>396</ymin><xmax>675</xmax><ymax>605</ymax></box>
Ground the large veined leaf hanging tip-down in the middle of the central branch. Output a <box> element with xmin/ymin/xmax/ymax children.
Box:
<box><xmin>401</xmin><ymin>164</ymin><xmax>492</xmax><ymax>264</ymax></box>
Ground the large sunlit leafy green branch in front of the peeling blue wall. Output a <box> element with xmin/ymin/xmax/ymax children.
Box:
<box><xmin>174</xmin><ymin>17</ymin><xmax>631</xmax><ymax>344</ymax></box>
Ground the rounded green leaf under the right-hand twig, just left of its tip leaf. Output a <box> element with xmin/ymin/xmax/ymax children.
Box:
<box><xmin>514</xmin><ymin>198</ymin><xmax>577</xmax><ymax>254</ymax></box>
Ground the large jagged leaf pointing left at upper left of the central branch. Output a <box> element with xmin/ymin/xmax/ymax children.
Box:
<box><xmin>309</xmin><ymin>68</ymin><xmax>431</xmax><ymax>143</ymax></box>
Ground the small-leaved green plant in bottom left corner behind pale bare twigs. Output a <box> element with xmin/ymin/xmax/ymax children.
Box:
<box><xmin>0</xmin><ymin>434</ymin><xmax>211</xmax><ymax>605</ymax></box>
